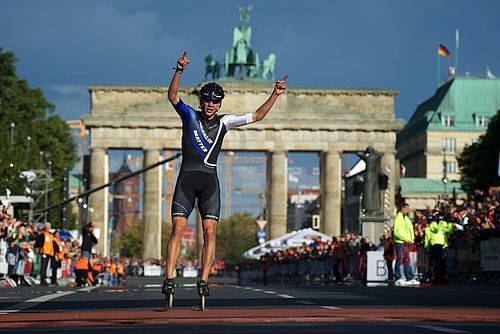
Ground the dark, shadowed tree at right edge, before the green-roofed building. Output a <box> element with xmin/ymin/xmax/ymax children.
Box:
<box><xmin>458</xmin><ymin>110</ymin><xmax>500</xmax><ymax>191</ymax></box>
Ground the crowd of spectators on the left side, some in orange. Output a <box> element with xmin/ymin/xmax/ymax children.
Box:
<box><xmin>0</xmin><ymin>206</ymin><xmax>132</xmax><ymax>286</ymax></box>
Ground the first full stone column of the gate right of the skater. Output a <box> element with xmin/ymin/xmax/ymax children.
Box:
<box><xmin>267</xmin><ymin>151</ymin><xmax>288</xmax><ymax>239</ymax></box>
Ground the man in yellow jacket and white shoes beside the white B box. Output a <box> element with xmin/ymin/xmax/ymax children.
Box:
<box><xmin>392</xmin><ymin>203</ymin><xmax>420</xmax><ymax>286</ymax></box>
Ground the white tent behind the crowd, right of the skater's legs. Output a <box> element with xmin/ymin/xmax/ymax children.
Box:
<box><xmin>243</xmin><ymin>228</ymin><xmax>332</xmax><ymax>260</ymax></box>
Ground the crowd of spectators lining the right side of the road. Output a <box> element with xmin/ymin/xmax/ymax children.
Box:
<box><xmin>240</xmin><ymin>187</ymin><xmax>500</xmax><ymax>284</ymax></box>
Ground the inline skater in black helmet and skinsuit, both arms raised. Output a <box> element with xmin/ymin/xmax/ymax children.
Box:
<box><xmin>162</xmin><ymin>51</ymin><xmax>287</xmax><ymax>310</ymax></box>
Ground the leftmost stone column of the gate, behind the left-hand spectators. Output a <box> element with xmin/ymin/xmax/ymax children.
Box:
<box><xmin>88</xmin><ymin>147</ymin><xmax>110</xmax><ymax>256</ymax></box>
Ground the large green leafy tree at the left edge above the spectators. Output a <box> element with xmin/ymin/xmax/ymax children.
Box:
<box><xmin>0</xmin><ymin>48</ymin><xmax>77</xmax><ymax>227</ymax></box>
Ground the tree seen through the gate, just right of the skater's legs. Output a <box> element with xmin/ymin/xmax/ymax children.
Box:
<box><xmin>215</xmin><ymin>213</ymin><xmax>258</xmax><ymax>265</ymax></box>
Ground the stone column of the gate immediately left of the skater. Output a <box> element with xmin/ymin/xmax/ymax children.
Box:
<box><xmin>142</xmin><ymin>148</ymin><xmax>162</xmax><ymax>259</ymax></box>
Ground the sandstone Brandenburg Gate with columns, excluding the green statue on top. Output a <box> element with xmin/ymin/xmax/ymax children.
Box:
<box><xmin>83</xmin><ymin>81</ymin><xmax>403</xmax><ymax>258</ymax></box>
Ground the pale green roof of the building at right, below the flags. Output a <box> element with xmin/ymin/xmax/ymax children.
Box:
<box><xmin>398</xmin><ymin>76</ymin><xmax>500</xmax><ymax>142</ymax></box>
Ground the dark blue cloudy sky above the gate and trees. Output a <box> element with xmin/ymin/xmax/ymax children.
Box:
<box><xmin>0</xmin><ymin>0</ymin><xmax>500</xmax><ymax>218</ymax></box>
